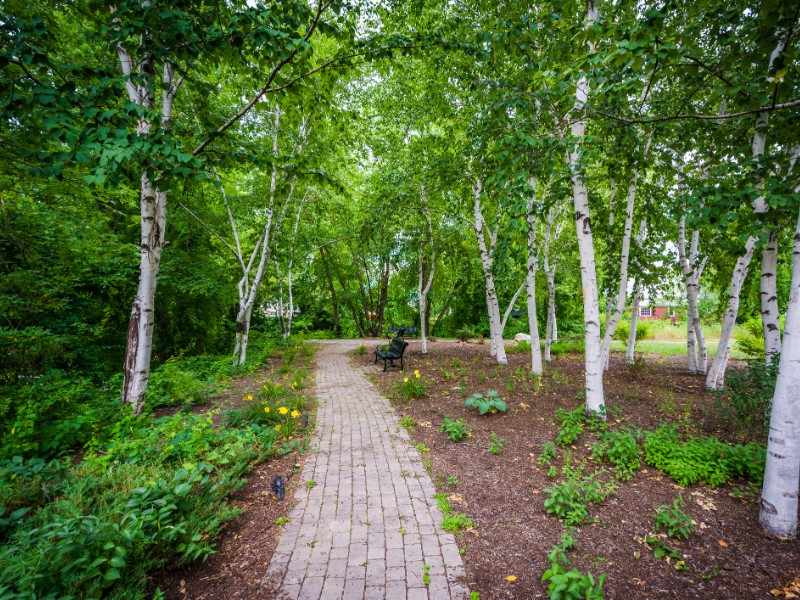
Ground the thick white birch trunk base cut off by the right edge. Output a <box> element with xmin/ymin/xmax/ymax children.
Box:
<box><xmin>759</xmin><ymin>206</ymin><xmax>800</xmax><ymax>538</ymax></box>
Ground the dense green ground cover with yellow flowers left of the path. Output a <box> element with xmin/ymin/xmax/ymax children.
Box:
<box><xmin>0</xmin><ymin>341</ymin><xmax>314</xmax><ymax>598</ymax></box>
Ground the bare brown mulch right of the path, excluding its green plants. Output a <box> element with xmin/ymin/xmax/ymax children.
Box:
<box><xmin>354</xmin><ymin>341</ymin><xmax>800</xmax><ymax>600</ymax></box>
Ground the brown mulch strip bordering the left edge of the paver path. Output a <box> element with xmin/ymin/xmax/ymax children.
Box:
<box><xmin>149</xmin><ymin>350</ymin><xmax>316</xmax><ymax>600</ymax></box>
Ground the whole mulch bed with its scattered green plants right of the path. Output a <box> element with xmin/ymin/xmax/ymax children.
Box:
<box><xmin>358</xmin><ymin>341</ymin><xmax>800</xmax><ymax>599</ymax></box>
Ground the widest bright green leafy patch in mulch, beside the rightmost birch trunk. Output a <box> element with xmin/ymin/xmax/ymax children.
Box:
<box><xmin>644</xmin><ymin>425</ymin><xmax>766</xmax><ymax>487</ymax></box>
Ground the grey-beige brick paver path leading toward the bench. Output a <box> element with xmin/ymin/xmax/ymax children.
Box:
<box><xmin>266</xmin><ymin>341</ymin><xmax>468</xmax><ymax>600</ymax></box>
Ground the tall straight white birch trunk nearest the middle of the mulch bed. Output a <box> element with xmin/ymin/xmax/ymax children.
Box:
<box><xmin>567</xmin><ymin>0</ymin><xmax>606</xmax><ymax>419</ymax></box>
